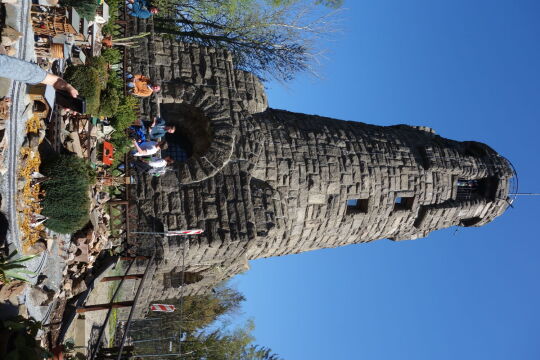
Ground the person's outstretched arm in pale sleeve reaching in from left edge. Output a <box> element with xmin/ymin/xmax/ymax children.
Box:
<box><xmin>0</xmin><ymin>49</ymin><xmax>79</xmax><ymax>97</ymax></box>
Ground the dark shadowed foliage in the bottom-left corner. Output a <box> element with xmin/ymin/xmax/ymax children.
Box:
<box><xmin>0</xmin><ymin>315</ymin><xmax>51</xmax><ymax>360</ymax></box>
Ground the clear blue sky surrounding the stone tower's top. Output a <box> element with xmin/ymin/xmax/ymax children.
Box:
<box><xmin>233</xmin><ymin>0</ymin><xmax>540</xmax><ymax>360</ymax></box>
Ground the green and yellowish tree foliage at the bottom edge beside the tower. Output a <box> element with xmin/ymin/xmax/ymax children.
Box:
<box><xmin>130</xmin><ymin>285</ymin><xmax>280</xmax><ymax>360</ymax></box>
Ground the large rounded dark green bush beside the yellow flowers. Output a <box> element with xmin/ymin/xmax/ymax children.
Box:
<box><xmin>41</xmin><ymin>155</ymin><xmax>95</xmax><ymax>234</ymax></box>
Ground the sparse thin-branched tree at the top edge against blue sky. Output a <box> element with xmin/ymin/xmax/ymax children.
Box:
<box><xmin>154</xmin><ymin>0</ymin><xmax>341</xmax><ymax>81</ymax></box>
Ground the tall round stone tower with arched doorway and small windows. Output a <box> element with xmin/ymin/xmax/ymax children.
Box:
<box><xmin>123</xmin><ymin>31</ymin><xmax>513</xmax><ymax>312</ymax></box>
